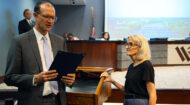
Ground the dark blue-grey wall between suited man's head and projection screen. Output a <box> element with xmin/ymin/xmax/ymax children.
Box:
<box><xmin>53</xmin><ymin>0</ymin><xmax>104</xmax><ymax>40</ymax></box>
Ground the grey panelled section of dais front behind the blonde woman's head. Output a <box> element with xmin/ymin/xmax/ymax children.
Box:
<box><xmin>117</xmin><ymin>44</ymin><xmax>168</xmax><ymax>70</ymax></box>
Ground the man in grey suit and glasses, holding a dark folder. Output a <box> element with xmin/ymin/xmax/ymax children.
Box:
<box><xmin>4</xmin><ymin>1</ymin><xmax>75</xmax><ymax>105</ymax></box>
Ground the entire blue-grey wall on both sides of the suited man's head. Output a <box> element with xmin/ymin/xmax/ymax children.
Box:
<box><xmin>0</xmin><ymin>0</ymin><xmax>104</xmax><ymax>76</ymax></box>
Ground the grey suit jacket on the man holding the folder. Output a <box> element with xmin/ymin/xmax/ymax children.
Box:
<box><xmin>4</xmin><ymin>30</ymin><xmax>66</xmax><ymax>105</ymax></box>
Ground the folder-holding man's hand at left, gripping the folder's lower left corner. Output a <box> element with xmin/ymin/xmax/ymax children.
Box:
<box><xmin>34</xmin><ymin>70</ymin><xmax>58</xmax><ymax>84</ymax></box>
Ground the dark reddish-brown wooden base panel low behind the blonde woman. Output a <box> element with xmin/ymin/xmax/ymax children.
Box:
<box><xmin>107</xmin><ymin>89</ymin><xmax>190</xmax><ymax>104</ymax></box>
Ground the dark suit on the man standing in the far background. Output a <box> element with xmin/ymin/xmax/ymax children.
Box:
<box><xmin>18</xmin><ymin>19</ymin><xmax>35</xmax><ymax>34</ymax></box>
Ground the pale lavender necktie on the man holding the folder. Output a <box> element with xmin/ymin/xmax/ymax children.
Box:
<box><xmin>42</xmin><ymin>36</ymin><xmax>58</xmax><ymax>95</ymax></box>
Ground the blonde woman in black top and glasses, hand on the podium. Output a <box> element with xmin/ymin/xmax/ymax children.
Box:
<box><xmin>101</xmin><ymin>35</ymin><xmax>157</xmax><ymax>105</ymax></box>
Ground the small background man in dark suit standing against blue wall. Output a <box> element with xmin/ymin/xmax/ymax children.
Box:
<box><xmin>18</xmin><ymin>9</ymin><xmax>34</xmax><ymax>34</ymax></box>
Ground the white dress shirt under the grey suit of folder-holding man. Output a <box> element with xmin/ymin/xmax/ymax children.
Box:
<box><xmin>33</xmin><ymin>28</ymin><xmax>53</xmax><ymax>96</ymax></box>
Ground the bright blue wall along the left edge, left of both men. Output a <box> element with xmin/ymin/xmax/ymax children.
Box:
<box><xmin>0</xmin><ymin>0</ymin><xmax>39</xmax><ymax>76</ymax></box>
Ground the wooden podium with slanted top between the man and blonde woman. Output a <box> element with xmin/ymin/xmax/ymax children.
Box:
<box><xmin>66</xmin><ymin>67</ymin><xmax>111</xmax><ymax>105</ymax></box>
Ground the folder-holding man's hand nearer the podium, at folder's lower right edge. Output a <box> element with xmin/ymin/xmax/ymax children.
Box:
<box><xmin>61</xmin><ymin>74</ymin><xmax>75</xmax><ymax>86</ymax></box>
